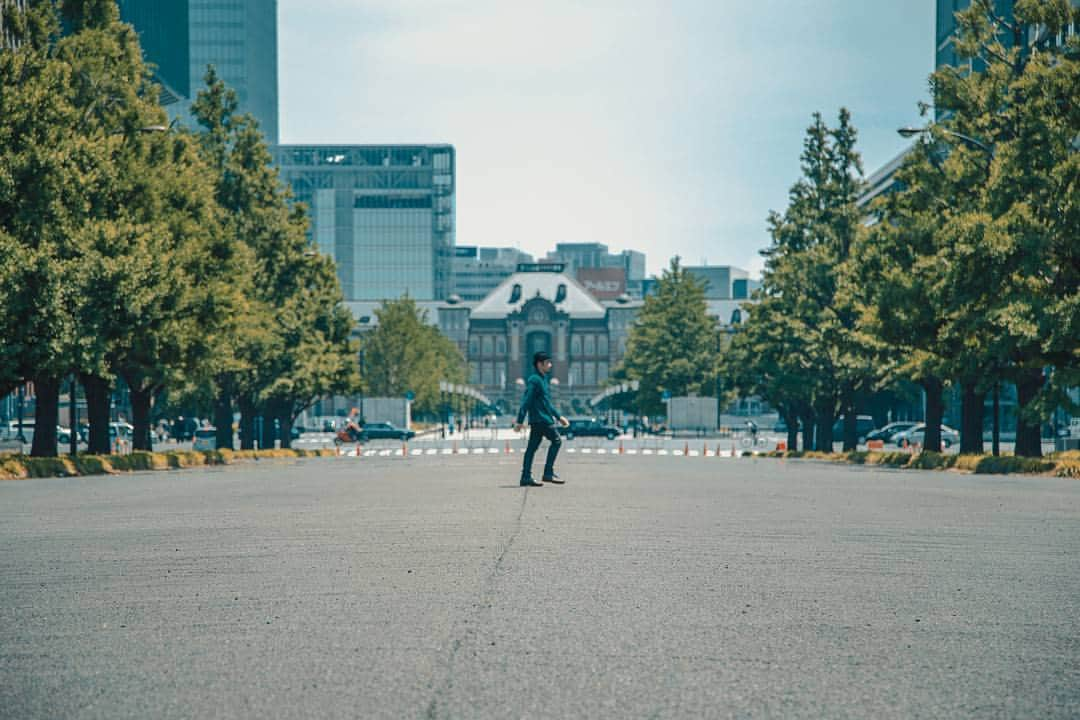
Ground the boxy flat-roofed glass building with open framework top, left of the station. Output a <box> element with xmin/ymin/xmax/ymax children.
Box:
<box><xmin>273</xmin><ymin>145</ymin><xmax>456</xmax><ymax>301</ymax></box>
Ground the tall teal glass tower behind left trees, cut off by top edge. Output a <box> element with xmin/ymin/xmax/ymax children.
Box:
<box><xmin>119</xmin><ymin>0</ymin><xmax>278</xmax><ymax>145</ymax></box>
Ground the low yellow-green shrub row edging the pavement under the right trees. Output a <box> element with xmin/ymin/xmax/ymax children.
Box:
<box><xmin>766</xmin><ymin>450</ymin><xmax>1080</xmax><ymax>477</ymax></box>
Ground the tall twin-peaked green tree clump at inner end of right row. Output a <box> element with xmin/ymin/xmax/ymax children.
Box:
<box><xmin>751</xmin><ymin>108</ymin><xmax>876</xmax><ymax>451</ymax></box>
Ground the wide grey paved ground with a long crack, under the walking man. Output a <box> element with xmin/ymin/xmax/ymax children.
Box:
<box><xmin>0</xmin><ymin>450</ymin><xmax>1080</xmax><ymax>720</ymax></box>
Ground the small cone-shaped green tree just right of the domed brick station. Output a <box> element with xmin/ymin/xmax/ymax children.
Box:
<box><xmin>617</xmin><ymin>257</ymin><xmax>720</xmax><ymax>415</ymax></box>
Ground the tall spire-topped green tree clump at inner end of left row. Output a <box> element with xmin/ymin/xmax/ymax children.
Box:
<box><xmin>192</xmin><ymin>68</ymin><xmax>359</xmax><ymax>447</ymax></box>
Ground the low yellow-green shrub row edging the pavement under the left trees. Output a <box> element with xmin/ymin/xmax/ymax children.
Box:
<box><xmin>0</xmin><ymin>449</ymin><xmax>335</xmax><ymax>480</ymax></box>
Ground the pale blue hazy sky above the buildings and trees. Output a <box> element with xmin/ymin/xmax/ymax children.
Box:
<box><xmin>278</xmin><ymin>0</ymin><xmax>934</xmax><ymax>274</ymax></box>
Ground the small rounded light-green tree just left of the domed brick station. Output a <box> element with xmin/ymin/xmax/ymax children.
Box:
<box><xmin>361</xmin><ymin>296</ymin><xmax>467</xmax><ymax>412</ymax></box>
